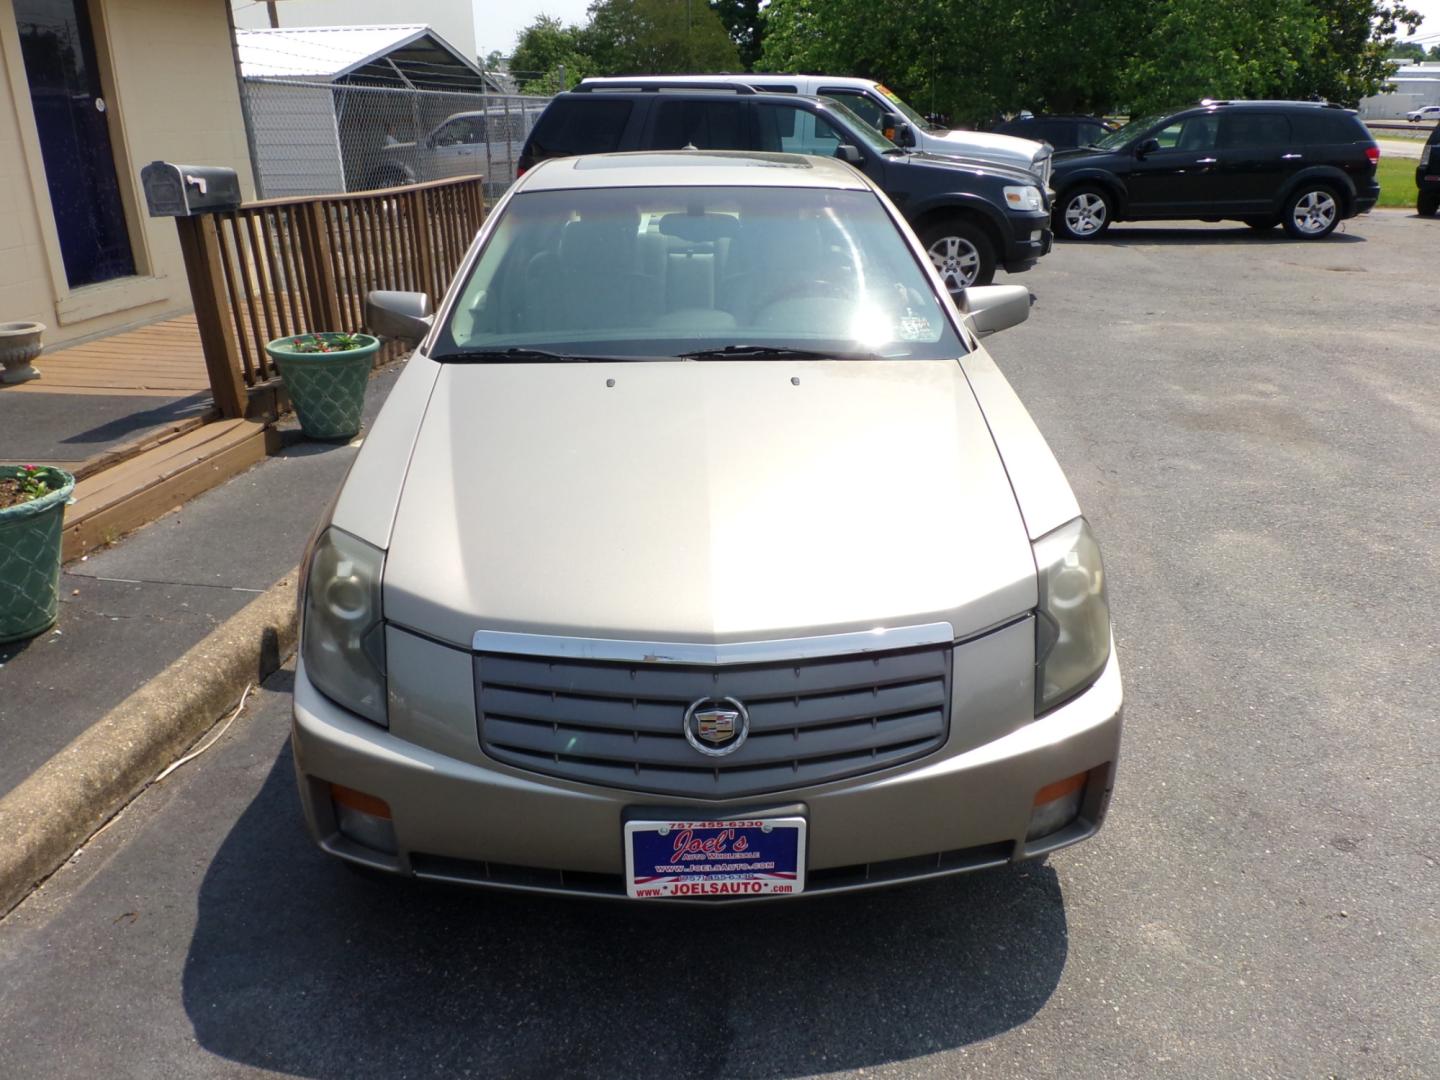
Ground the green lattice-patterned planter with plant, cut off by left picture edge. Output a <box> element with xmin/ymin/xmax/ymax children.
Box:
<box><xmin>0</xmin><ymin>465</ymin><xmax>75</xmax><ymax>644</ymax></box>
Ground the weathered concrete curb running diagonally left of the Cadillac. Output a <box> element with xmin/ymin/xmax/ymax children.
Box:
<box><xmin>0</xmin><ymin>570</ymin><xmax>297</xmax><ymax>916</ymax></box>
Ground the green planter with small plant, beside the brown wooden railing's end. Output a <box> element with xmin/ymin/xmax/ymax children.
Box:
<box><xmin>265</xmin><ymin>333</ymin><xmax>380</xmax><ymax>439</ymax></box>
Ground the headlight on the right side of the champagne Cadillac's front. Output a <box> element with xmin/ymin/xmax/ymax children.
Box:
<box><xmin>1034</xmin><ymin>517</ymin><xmax>1110</xmax><ymax>716</ymax></box>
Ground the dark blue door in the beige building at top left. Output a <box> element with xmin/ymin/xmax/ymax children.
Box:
<box><xmin>14</xmin><ymin>0</ymin><xmax>135</xmax><ymax>288</ymax></box>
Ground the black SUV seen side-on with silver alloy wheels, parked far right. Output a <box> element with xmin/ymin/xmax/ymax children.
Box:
<box><xmin>1050</xmin><ymin>101</ymin><xmax>1380</xmax><ymax>240</ymax></box>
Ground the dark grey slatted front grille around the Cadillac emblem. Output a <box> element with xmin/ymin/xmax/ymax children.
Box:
<box><xmin>475</xmin><ymin>644</ymin><xmax>952</xmax><ymax>799</ymax></box>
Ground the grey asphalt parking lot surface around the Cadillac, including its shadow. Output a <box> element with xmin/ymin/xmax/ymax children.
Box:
<box><xmin>0</xmin><ymin>212</ymin><xmax>1440</xmax><ymax>1080</ymax></box>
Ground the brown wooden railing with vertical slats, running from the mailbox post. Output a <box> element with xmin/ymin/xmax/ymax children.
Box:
<box><xmin>176</xmin><ymin>177</ymin><xmax>485</xmax><ymax>416</ymax></box>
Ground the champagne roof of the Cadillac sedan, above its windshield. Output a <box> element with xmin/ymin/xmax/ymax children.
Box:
<box><xmin>516</xmin><ymin>150</ymin><xmax>871</xmax><ymax>193</ymax></box>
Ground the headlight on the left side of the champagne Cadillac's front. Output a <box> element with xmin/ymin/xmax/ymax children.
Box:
<box><xmin>300</xmin><ymin>527</ymin><xmax>386</xmax><ymax>724</ymax></box>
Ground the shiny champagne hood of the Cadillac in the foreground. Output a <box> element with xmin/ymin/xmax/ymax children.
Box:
<box><xmin>383</xmin><ymin>360</ymin><xmax>1035</xmax><ymax>647</ymax></box>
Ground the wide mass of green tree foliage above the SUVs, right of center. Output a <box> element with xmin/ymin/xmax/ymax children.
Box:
<box><xmin>760</xmin><ymin>0</ymin><xmax>1418</xmax><ymax>121</ymax></box>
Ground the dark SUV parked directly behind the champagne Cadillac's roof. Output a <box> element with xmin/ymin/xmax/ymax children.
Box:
<box><xmin>520</xmin><ymin>82</ymin><xmax>1051</xmax><ymax>292</ymax></box>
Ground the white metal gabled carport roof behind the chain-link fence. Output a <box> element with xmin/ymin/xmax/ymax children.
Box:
<box><xmin>235</xmin><ymin>23</ymin><xmax>498</xmax><ymax>91</ymax></box>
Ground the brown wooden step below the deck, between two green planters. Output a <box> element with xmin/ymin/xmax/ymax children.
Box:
<box><xmin>62</xmin><ymin>420</ymin><xmax>279</xmax><ymax>562</ymax></box>
